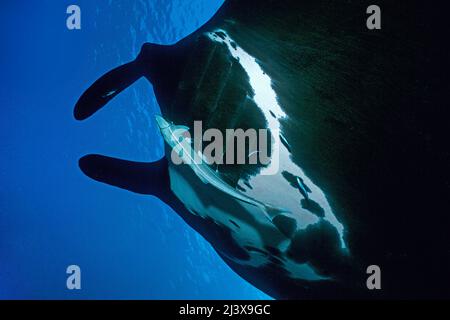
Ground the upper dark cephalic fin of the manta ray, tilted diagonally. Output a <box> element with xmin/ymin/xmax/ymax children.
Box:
<box><xmin>74</xmin><ymin>61</ymin><xmax>143</xmax><ymax>120</ymax></box>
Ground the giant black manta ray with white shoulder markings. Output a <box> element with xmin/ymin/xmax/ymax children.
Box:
<box><xmin>74</xmin><ymin>0</ymin><xmax>449</xmax><ymax>298</ymax></box>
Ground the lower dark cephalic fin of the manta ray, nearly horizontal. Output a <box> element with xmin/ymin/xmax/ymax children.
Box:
<box><xmin>79</xmin><ymin>155</ymin><xmax>170</xmax><ymax>198</ymax></box>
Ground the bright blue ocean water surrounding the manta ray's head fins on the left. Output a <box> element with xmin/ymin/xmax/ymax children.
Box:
<box><xmin>0</xmin><ymin>0</ymin><xmax>268</xmax><ymax>299</ymax></box>
